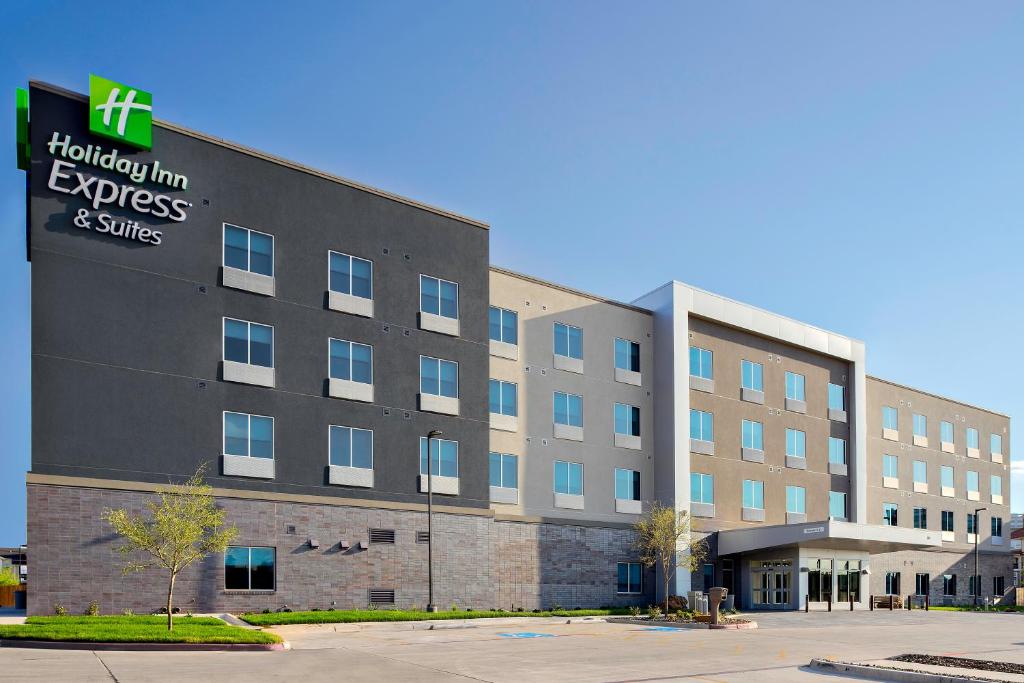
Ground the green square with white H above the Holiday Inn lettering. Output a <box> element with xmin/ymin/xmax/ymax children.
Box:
<box><xmin>89</xmin><ymin>74</ymin><xmax>153</xmax><ymax>150</ymax></box>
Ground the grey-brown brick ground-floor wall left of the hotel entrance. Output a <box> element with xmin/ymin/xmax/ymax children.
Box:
<box><xmin>28</xmin><ymin>484</ymin><xmax>653</xmax><ymax>614</ymax></box>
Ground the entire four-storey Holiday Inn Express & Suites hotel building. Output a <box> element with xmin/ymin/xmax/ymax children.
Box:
<box><xmin>19</xmin><ymin>78</ymin><xmax>1013</xmax><ymax>613</ymax></box>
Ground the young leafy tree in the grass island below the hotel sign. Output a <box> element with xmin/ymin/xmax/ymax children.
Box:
<box><xmin>103</xmin><ymin>465</ymin><xmax>238</xmax><ymax>631</ymax></box>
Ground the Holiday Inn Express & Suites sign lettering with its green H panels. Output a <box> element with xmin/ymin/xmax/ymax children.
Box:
<box><xmin>17</xmin><ymin>75</ymin><xmax>191</xmax><ymax>246</ymax></box>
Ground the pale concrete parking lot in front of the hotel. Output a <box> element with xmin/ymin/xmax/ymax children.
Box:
<box><xmin>0</xmin><ymin>611</ymin><xmax>1024</xmax><ymax>683</ymax></box>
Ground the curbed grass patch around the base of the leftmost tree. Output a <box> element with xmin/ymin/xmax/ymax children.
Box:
<box><xmin>0</xmin><ymin>616</ymin><xmax>281</xmax><ymax>644</ymax></box>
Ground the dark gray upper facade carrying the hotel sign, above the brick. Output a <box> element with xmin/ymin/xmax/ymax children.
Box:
<box><xmin>29</xmin><ymin>85</ymin><xmax>488</xmax><ymax>508</ymax></box>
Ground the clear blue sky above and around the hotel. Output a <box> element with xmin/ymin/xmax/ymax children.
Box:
<box><xmin>0</xmin><ymin>0</ymin><xmax>1024</xmax><ymax>545</ymax></box>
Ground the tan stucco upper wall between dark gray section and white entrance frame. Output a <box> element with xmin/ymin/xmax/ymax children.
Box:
<box><xmin>490</xmin><ymin>269</ymin><xmax>654</xmax><ymax>524</ymax></box>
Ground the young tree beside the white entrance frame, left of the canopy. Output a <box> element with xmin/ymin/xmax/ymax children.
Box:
<box><xmin>633</xmin><ymin>501</ymin><xmax>708</xmax><ymax>613</ymax></box>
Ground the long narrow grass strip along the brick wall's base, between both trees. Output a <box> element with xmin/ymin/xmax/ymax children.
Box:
<box><xmin>241</xmin><ymin>609</ymin><xmax>630</xmax><ymax>626</ymax></box>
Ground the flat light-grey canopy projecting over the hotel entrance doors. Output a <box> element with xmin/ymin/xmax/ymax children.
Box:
<box><xmin>718</xmin><ymin>519</ymin><xmax>942</xmax><ymax>556</ymax></box>
